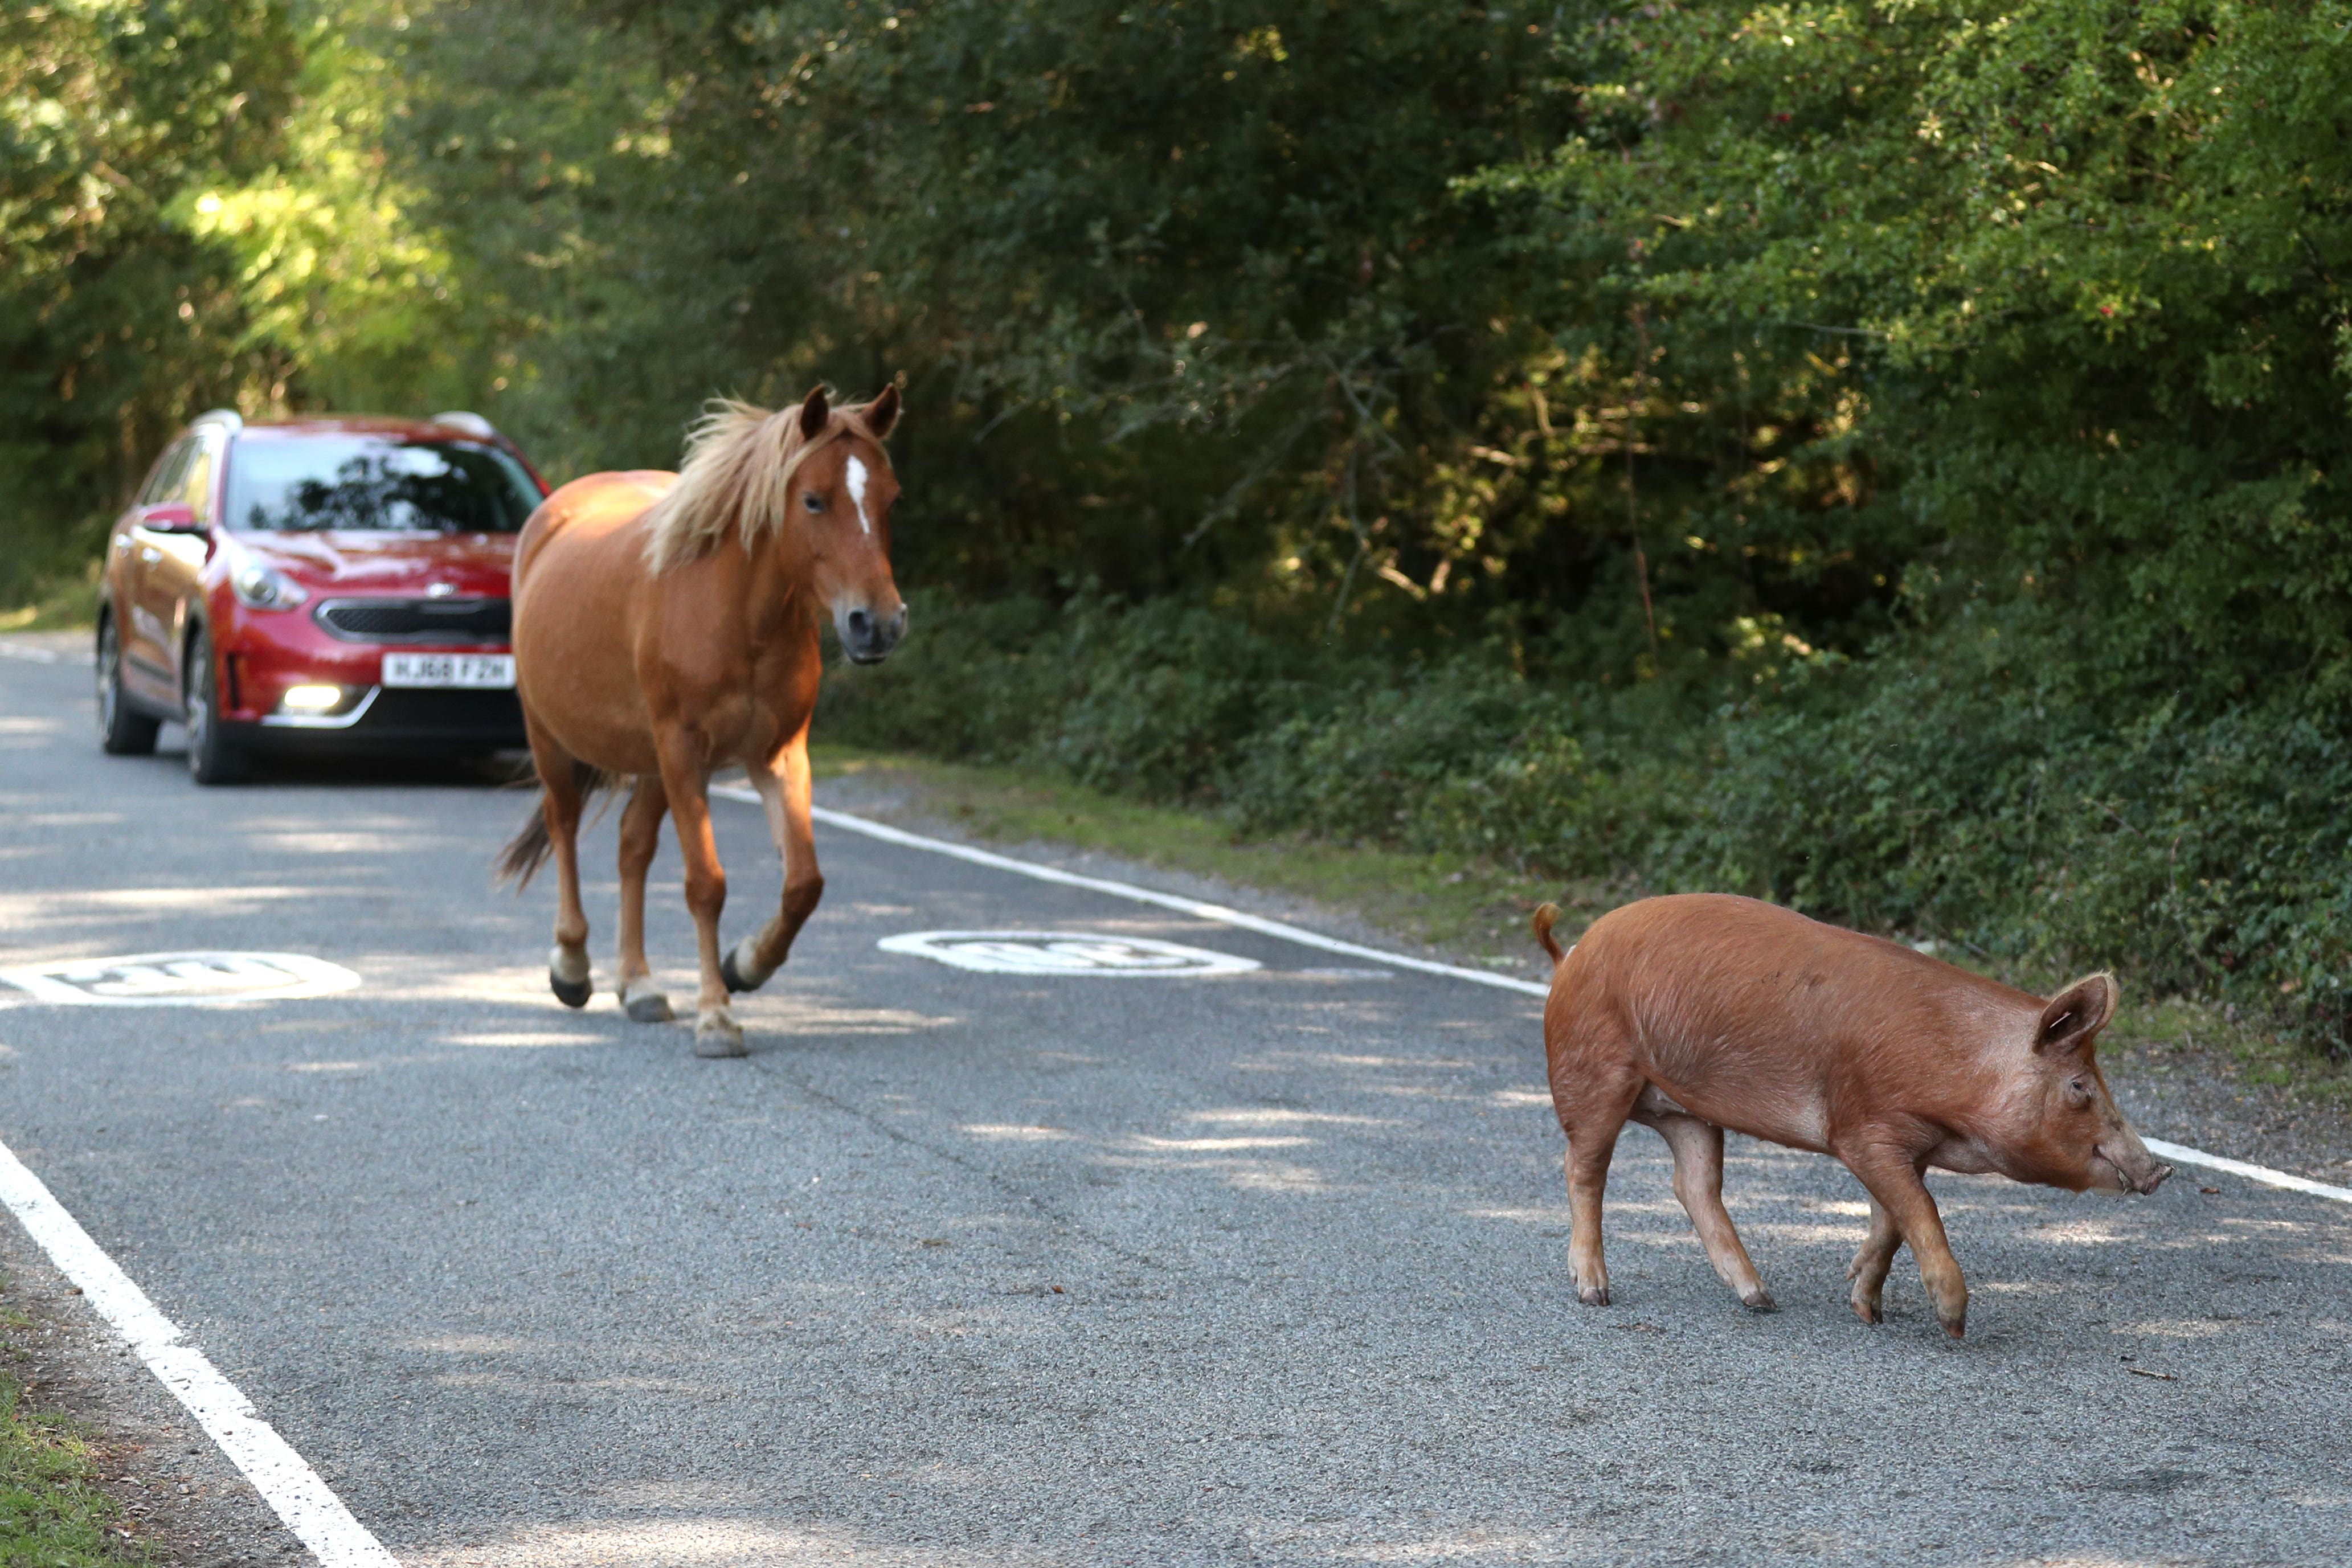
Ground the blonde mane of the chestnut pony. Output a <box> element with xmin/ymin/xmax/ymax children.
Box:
<box><xmin>644</xmin><ymin>398</ymin><xmax>880</xmax><ymax>576</ymax></box>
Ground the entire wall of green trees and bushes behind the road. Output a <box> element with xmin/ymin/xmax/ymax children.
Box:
<box><xmin>0</xmin><ymin>0</ymin><xmax>2352</xmax><ymax>1053</ymax></box>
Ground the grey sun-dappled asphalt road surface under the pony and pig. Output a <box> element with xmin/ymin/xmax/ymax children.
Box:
<box><xmin>0</xmin><ymin>644</ymin><xmax>2352</xmax><ymax>1568</ymax></box>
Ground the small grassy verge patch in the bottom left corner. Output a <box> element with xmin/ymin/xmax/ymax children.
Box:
<box><xmin>0</xmin><ymin>1307</ymin><xmax>150</xmax><ymax>1568</ymax></box>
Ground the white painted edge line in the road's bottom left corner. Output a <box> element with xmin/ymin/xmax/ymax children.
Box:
<box><xmin>0</xmin><ymin>1145</ymin><xmax>400</xmax><ymax>1568</ymax></box>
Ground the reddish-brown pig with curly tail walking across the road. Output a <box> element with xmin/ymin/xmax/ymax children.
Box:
<box><xmin>1533</xmin><ymin>893</ymin><xmax>2171</xmax><ymax>1340</ymax></box>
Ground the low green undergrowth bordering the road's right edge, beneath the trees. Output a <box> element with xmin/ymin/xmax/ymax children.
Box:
<box><xmin>819</xmin><ymin>597</ymin><xmax>2352</xmax><ymax>1051</ymax></box>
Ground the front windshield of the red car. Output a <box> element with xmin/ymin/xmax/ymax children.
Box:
<box><xmin>226</xmin><ymin>435</ymin><xmax>539</xmax><ymax>534</ymax></box>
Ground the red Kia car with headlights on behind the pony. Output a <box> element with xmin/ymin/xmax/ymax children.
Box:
<box><xmin>99</xmin><ymin>411</ymin><xmax>548</xmax><ymax>785</ymax></box>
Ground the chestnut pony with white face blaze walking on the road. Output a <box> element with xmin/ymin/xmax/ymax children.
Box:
<box><xmin>498</xmin><ymin>386</ymin><xmax>906</xmax><ymax>1055</ymax></box>
